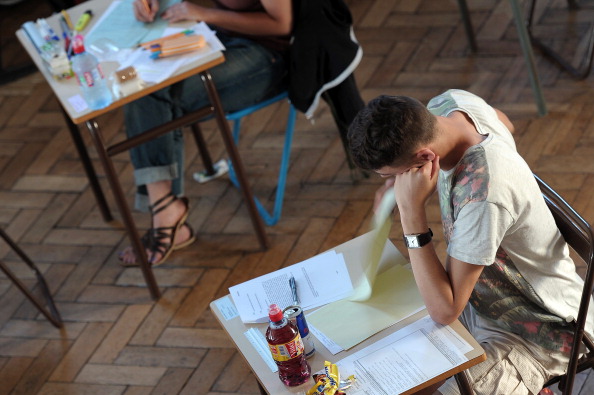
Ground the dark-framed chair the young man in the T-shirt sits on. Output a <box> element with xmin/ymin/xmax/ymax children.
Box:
<box><xmin>455</xmin><ymin>175</ymin><xmax>594</xmax><ymax>394</ymax></box>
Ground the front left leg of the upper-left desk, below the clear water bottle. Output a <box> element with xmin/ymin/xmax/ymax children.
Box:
<box><xmin>86</xmin><ymin>120</ymin><xmax>161</xmax><ymax>300</ymax></box>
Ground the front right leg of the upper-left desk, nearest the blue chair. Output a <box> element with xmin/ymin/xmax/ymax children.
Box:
<box><xmin>200</xmin><ymin>71</ymin><xmax>268</xmax><ymax>249</ymax></box>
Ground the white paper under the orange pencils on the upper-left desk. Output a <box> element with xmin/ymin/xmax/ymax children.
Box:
<box><xmin>119</xmin><ymin>22</ymin><xmax>225</xmax><ymax>84</ymax></box>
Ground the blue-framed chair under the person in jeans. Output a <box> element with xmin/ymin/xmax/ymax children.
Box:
<box><xmin>194</xmin><ymin>92</ymin><xmax>297</xmax><ymax>226</ymax></box>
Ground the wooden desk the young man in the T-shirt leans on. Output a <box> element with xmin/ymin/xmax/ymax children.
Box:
<box><xmin>210</xmin><ymin>233</ymin><xmax>486</xmax><ymax>395</ymax></box>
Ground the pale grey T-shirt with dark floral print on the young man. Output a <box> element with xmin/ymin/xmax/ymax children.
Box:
<box><xmin>427</xmin><ymin>90</ymin><xmax>592</xmax><ymax>352</ymax></box>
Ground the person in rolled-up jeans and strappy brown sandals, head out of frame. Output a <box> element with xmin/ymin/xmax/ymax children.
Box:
<box><xmin>120</xmin><ymin>0</ymin><xmax>292</xmax><ymax>265</ymax></box>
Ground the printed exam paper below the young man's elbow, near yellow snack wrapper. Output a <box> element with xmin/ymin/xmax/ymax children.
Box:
<box><xmin>336</xmin><ymin>316</ymin><xmax>471</xmax><ymax>395</ymax></box>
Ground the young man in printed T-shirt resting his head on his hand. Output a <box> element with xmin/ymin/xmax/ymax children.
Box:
<box><xmin>348</xmin><ymin>90</ymin><xmax>593</xmax><ymax>395</ymax></box>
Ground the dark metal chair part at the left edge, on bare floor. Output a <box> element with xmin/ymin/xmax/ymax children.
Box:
<box><xmin>0</xmin><ymin>229</ymin><xmax>63</xmax><ymax>328</ymax></box>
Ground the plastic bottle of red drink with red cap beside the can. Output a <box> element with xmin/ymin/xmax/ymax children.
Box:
<box><xmin>266</xmin><ymin>304</ymin><xmax>311</xmax><ymax>387</ymax></box>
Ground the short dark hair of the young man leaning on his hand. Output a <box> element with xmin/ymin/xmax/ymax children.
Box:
<box><xmin>347</xmin><ymin>95</ymin><xmax>436</xmax><ymax>170</ymax></box>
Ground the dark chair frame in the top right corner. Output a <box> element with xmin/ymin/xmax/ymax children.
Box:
<box><xmin>526</xmin><ymin>0</ymin><xmax>594</xmax><ymax>80</ymax></box>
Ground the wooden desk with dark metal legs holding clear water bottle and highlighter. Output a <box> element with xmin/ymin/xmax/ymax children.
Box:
<box><xmin>16</xmin><ymin>0</ymin><xmax>268</xmax><ymax>299</ymax></box>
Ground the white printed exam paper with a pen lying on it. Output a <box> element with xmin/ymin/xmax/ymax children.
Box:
<box><xmin>229</xmin><ymin>251</ymin><xmax>353</xmax><ymax>322</ymax></box>
